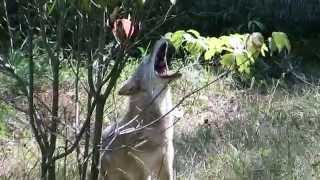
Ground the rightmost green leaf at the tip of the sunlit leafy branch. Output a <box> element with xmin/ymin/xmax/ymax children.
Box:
<box><xmin>272</xmin><ymin>32</ymin><xmax>291</xmax><ymax>53</ymax></box>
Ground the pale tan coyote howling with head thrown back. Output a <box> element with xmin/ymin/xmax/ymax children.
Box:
<box><xmin>100</xmin><ymin>39</ymin><xmax>181</xmax><ymax>180</ymax></box>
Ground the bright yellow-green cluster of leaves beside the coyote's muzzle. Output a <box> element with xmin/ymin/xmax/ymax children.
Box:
<box><xmin>165</xmin><ymin>30</ymin><xmax>291</xmax><ymax>81</ymax></box>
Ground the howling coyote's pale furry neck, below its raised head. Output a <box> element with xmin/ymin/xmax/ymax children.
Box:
<box><xmin>124</xmin><ymin>87</ymin><xmax>172</xmax><ymax>124</ymax></box>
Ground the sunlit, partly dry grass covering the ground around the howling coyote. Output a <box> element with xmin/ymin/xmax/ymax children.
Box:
<box><xmin>0</xmin><ymin>59</ymin><xmax>320</xmax><ymax>180</ymax></box>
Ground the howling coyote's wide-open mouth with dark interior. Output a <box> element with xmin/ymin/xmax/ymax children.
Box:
<box><xmin>154</xmin><ymin>41</ymin><xmax>181</xmax><ymax>79</ymax></box>
